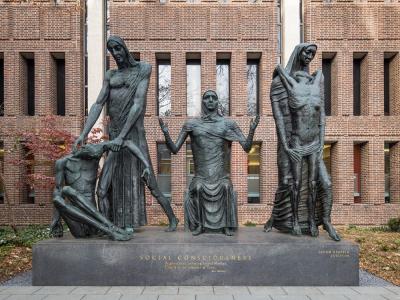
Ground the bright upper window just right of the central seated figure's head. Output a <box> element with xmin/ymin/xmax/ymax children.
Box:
<box><xmin>216</xmin><ymin>54</ymin><xmax>230</xmax><ymax>115</ymax></box>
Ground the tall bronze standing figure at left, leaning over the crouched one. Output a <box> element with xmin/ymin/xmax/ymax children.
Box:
<box><xmin>75</xmin><ymin>36</ymin><xmax>178</xmax><ymax>231</ymax></box>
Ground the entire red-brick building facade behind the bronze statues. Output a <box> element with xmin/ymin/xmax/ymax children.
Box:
<box><xmin>0</xmin><ymin>0</ymin><xmax>400</xmax><ymax>224</ymax></box>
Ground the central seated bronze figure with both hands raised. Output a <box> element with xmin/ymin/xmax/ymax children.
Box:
<box><xmin>159</xmin><ymin>91</ymin><xmax>259</xmax><ymax>236</ymax></box>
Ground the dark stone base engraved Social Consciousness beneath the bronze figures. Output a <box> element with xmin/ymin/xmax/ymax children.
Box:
<box><xmin>33</xmin><ymin>227</ymin><xmax>359</xmax><ymax>286</ymax></box>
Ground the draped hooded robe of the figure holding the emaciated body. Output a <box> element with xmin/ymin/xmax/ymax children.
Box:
<box><xmin>267</xmin><ymin>44</ymin><xmax>332</xmax><ymax>233</ymax></box>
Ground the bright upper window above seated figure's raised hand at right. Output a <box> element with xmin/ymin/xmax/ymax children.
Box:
<box><xmin>246</xmin><ymin>58</ymin><xmax>260</xmax><ymax>116</ymax></box>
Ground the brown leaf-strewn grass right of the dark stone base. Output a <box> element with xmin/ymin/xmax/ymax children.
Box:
<box><xmin>339</xmin><ymin>226</ymin><xmax>400</xmax><ymax>285</ymax></box>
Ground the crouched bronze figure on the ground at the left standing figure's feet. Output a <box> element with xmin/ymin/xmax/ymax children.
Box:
<box><xmin>50</xmin><ymin>141</ymin><xmax>150</xmax><ymax>241</ymax></box>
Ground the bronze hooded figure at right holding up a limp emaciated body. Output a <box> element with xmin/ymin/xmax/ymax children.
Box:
<box><xmin>265</xmin><ymin>43</ymin><xmax>340</xmax><ymax>241</ymax></box>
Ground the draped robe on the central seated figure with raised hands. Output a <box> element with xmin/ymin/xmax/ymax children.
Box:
<box><xmin>184</xmin><ymin>116</ymin><xmax>245</xmax><ymax>231</ymax></box>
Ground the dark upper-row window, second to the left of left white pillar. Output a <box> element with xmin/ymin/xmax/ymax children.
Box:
<box><xmin>21</xmin><ymin>53</ymin><xmax>35</xmax><ymax>116</ymax></box>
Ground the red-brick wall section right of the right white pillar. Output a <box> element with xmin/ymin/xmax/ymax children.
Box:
<box><xmin>304</xmin><ymin>0</ymin><xmax>400</xmax><ymax>224</ymax></box>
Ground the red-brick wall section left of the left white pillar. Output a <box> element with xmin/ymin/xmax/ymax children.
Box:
<box><xmin>0</xmin><ymin>0</ymin><xmax>84</xmax><ymax>224</ymax></box>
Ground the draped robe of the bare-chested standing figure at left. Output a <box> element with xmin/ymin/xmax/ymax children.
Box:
<box><xmin>100</xmin><ymin>62</ymin><xmax>151</xmax><ymax>228</ymax></box>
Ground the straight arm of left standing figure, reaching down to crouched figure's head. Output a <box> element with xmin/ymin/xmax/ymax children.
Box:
<box><xmin>74</xmin><ymin>72</ymin><xmax>110</xmax><ymax>151</ymax></box>
